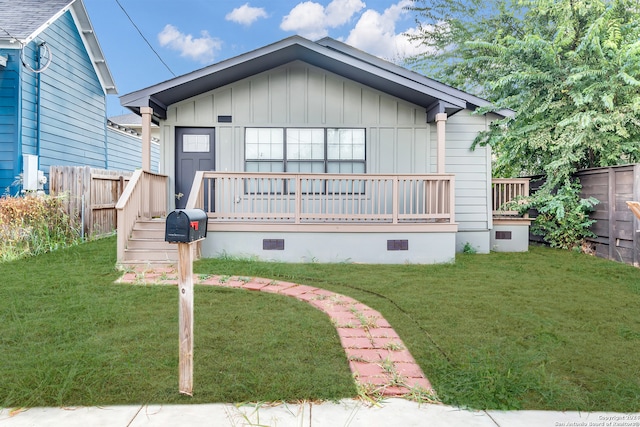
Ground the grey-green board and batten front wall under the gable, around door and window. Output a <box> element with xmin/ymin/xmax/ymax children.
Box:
<box><xmin>161</xmin><ymin>61</ymin><xmax>433</xmax><ymax>175</ymax></box>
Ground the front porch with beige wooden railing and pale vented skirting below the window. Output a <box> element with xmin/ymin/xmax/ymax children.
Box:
<box><xmin>186</xmin><ymin>172</ymin><xmax>458</xmax><ymax>263</ymax></box>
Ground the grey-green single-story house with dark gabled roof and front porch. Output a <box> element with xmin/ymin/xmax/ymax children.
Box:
<box><xmin>119</xmin><ymin>36</ymin><xmax>528</xmax><ymax>263</ymax></box>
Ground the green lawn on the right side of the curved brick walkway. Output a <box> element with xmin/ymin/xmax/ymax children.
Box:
<box><xmin>196</xmin><ymin>247</ymin><xmax>640</xmax><ymax>412</ymax></box>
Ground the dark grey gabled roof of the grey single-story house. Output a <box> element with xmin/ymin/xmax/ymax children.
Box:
<box><xmin>120</xmin><ymin>36</ymin><xmax>510</xmax><ymax>121</ymax></box>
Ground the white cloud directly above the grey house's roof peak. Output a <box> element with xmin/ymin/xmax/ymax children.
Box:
<box><xmin>280</xmin><ymin>0</ymin><xmax>365</xmax><ymax>40</ymax></box>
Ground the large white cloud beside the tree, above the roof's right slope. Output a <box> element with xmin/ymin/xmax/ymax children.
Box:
<box><xmin>345</xmin><ymin>0</ymin><xmax>424</xmax><ymax>61</ymax></box>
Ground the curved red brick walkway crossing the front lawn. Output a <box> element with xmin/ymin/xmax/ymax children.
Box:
<box><xmin>118</xmin><ymin>268</ymin><xmax>435</xmax><ymax>399</ymax></box>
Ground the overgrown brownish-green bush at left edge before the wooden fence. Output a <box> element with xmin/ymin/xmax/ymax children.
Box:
<box><xmin>0</xmin><ymin>195</ymin><xmax>79</xmax><ymax>261</ymax></box>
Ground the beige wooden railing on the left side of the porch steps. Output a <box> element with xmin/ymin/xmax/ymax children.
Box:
<box><xmin>116</xmin><ymin>170</ymin><xmax>168</xmax><ymax>262</ymax></box>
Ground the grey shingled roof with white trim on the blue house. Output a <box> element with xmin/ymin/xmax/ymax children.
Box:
<box><xmin>0</xmin><ymin>0</ymin><xmax>118</xmax><ymax>94</ymax></box>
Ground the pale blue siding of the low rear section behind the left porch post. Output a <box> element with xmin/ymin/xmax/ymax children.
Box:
<box><xmin>107</xmin><ymin>128</ymin><xmax>160</xmax><ymax>172</ymax></box>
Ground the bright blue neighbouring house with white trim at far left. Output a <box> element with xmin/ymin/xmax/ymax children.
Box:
<box><xmin>0</xmin><ymin>0</ymin><xmax>154</xmax><ymax>194</ymax></box>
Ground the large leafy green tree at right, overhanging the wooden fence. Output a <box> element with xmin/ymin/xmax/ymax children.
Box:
<box><xmin>412</xmin><ymin>0</ymin><xmax>640</xmax><ymax>246</ymax></box>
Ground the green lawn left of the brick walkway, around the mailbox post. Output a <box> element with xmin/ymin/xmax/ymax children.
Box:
<box><xmin>0</xmin><ymin>238</ymin><xmax>356</xmax><ymax>407</ymax></box>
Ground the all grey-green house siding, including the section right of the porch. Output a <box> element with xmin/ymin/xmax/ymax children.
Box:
<box><xmin>160</xmin><ymin>61</ymin><xmax>491</xmax><ymax>237</ymax></box>
